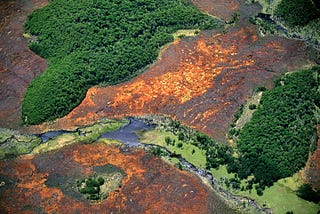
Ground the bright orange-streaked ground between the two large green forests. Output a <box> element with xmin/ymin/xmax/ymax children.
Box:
<box><xmin>31</xmin><ymin>26</ymin><xmax>307</xmax><ymax>141</ymax></box>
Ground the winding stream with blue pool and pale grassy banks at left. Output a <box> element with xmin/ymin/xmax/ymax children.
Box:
<box><xmin>0</xmin><ymin>118</ymin><xmax>262</xmax><ymax>213</ymax></box>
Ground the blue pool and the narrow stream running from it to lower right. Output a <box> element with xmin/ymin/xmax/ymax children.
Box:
<box><xmin>101</xmin><ymin>116</ymin><xmax>271</xmax><ymax>213</ymax></box>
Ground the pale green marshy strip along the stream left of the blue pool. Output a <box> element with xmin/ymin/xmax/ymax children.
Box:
<box><xmin>0</xmin><ymin>119</ymin><xmax>128</xmax><ymax>160</ymax></box>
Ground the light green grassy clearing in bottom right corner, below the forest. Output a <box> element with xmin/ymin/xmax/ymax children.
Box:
<box><xmin>211</xmin><ymin>166</ymin><xmax>320</xmax><ymax>214</ymax></box>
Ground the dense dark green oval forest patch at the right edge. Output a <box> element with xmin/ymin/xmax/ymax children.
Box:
<box><xmin>228</xmin><ymin>67</ymin><xmax>320</xmax><ymax>189</ymax></box>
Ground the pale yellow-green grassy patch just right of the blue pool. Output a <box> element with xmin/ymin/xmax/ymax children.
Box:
<box><xmin>139</xmin><ymin>130</ymin><xmax>206</xmax><ymax>168</ymax></box>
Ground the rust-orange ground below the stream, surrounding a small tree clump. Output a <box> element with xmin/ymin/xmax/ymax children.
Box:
<box><xmin>0</xmin><ymin>144</ymin><xmax>229</xmax><ymax>213</ymax></box>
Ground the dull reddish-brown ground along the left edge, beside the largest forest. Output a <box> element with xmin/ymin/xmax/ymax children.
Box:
<box><xmin>0</xmin><ymin>0</ymin><xmax>47</xmax><ymax>127</ymax></box>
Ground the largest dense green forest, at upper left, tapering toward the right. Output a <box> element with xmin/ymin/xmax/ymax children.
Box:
<box><xmin>22</xmin><ymin>0</ymin><xmax>219</xmax><ymax>124</ymax></box>
